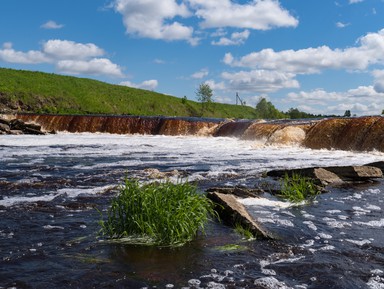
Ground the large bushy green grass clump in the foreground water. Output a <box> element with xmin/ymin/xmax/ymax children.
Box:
<box><xmin>100</xmin><ymin>179</ymin><xmax>215</xmax><ymax>246</ymax></box>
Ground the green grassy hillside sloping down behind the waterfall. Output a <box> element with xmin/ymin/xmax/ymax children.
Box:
<box><xmin>0</xmin><ymin>68</ymin><xmax>255</xmax><ymax>118</ymax></box>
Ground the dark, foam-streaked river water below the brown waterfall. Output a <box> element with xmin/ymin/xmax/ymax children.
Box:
<box><xmin>0</xmin><ymin>133</ymin><xmax>384</xmax><ymax>288</ymax></box>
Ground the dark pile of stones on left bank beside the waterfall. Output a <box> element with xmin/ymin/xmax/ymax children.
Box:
<box><xmin>0</xmin><ymin>117</ymin><xmax>46</xmax><ymax>135</ymax></box>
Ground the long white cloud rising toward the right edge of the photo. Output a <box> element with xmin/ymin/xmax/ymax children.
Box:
<box><xmin>223</xmin><ymin>29</ymin><xmax>384</xmax><ymax>74</ymax></box>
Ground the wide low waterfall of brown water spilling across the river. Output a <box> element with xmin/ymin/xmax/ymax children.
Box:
<box><xmin>10</xmin><ymin>114</ymin><xmax>384</xmax><ymax>151</ymax></box>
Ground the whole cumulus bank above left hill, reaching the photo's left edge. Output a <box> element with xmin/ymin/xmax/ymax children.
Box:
<box><xmin>0</xmin><ymin>39</ymin><xmax>124</xmax><ymax>77</ymax></box>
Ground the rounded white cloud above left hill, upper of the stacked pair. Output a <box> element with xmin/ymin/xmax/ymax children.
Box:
<box><xmin>43</xmin><ymin>39</ymin><xmax>105</xmax><ymax>60</ymax></box>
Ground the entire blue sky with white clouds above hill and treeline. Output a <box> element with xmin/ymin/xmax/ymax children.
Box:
<box><xmin>0</xmin><ymin>0</ymin><xmax>384</xmax><ymax>115</ymax></box>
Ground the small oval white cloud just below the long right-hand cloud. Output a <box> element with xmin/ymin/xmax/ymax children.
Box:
<box><xmin>221</xmin><ymin>70</ymin><xmax>299</xmax><ymax>92</ymax></box>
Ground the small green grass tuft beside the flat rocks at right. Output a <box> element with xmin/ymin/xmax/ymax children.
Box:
<box><xmin>280</xmin><ymin>173</ymin><xmax>320</xmax><ymax>203</ymax></box>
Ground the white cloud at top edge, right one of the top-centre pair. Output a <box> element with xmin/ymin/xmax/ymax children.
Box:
<box><xmin>189</xmin><ymin>0</ymin><xmax>298</xmax><ymax>30</ymax></box>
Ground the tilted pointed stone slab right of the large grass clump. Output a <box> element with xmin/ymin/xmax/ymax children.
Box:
<box><xmin>207</xmin><ymin>192</ymin><xmax>276</xmax><ymax>239</ymax></box>
